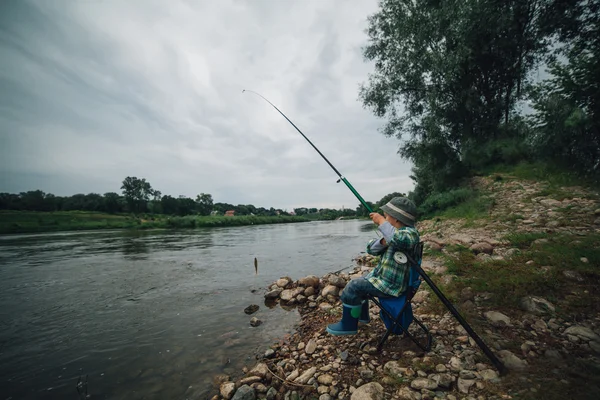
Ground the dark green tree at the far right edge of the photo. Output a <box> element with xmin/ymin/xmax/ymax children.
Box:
<box><xmin>531</xmin><ymin>0</ymin><xmax>600</xmax><ymax>178</ymax></box>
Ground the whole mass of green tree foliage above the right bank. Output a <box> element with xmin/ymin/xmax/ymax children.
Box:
<box><xmin>359</xmin><ymin>0</ymin><xmax>600</xmax><ymax>209</ymax></box>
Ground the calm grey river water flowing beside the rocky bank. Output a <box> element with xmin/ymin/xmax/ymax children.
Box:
<box><xmin>0</xmin><ymin>220</ymin><xmax>374</xmax><ymax>400</ymax></box>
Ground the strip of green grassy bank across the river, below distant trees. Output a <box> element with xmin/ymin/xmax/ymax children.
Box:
<box><xmin>0</xmin><ymin>211</ymin><xmax>308</xmax><ymax>233</ymax></box>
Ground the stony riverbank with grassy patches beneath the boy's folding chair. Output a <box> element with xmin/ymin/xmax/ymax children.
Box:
<box><xmin>207</xmin><ymin>177</ymin><xmax>600</xmax><ymax>400</ymax></box>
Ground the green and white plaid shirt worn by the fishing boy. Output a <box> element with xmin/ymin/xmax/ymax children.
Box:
<box><xmin>365</xmin><ymin>222</ymin><xmax>420</xmax><ymax>297</ymax></box>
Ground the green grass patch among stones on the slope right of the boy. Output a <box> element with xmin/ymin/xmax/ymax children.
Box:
<box><xmin>424</xmin><ymin>233</ymin><xmax>600</xmax><ymax>319</ymax></box>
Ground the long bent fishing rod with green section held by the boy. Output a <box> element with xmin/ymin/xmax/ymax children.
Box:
<box><xmin>242</xmin><ymin>89</ymin><xmax>508</xmax><ymax>375</ymax></box>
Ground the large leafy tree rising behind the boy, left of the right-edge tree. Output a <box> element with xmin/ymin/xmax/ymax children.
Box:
<box><xmin>360</xmin><ymin>0</ymin><xmax>550</xmax><ymax>196</ymax></box>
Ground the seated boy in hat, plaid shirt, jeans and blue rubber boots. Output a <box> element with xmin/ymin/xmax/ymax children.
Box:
<box><xmin>327</xmin><ymin>197</ymin><xmax>420</xmax><ymax>335</ymax></box>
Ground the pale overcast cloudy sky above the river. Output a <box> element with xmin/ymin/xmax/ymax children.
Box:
<box><xmin>0</xmin><ymin>0</ymin><xmax>413</xmax><ymax>210</ymax></box>
